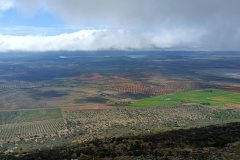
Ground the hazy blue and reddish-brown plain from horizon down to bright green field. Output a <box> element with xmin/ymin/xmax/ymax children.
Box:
<box><xmin>0</xmin><ymin>51</ymin><xmax>240</xmax><ymax>110</ymax></box>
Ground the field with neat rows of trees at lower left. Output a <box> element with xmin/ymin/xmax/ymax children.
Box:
<box><xmin>0</xmin><ymin>109</ymin><xmax>66</xmax><ymax>143</ymax></box>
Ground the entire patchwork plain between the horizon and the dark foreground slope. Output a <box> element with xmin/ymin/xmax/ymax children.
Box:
<box><xmin>0</xmin><ymin>51</ymin><xmax>240</xmax><ymax>159</ymax></box>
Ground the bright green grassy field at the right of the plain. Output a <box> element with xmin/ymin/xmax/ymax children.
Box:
<box><xmin>129</xmin><ymin>89</ymin><xmax>240</xmax><ymax>107</ymax></box>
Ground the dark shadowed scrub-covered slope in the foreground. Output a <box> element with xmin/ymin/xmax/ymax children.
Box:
<box><xmin>0</xmin><ymin>123</ymin><xmax>240</xmax><ymax>160</ymax></box>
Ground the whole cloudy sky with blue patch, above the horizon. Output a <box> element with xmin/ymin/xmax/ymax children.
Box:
<box><xmin>0</xmin><ymin>0</ymin><xmax>240</xmax><ymax>52</ymax></box>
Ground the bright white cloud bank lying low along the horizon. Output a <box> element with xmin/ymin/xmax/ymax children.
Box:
<box><xmin>0</xmin><ymin>29</ymin><xmax>201</xmax><ymax>52</ymax></box>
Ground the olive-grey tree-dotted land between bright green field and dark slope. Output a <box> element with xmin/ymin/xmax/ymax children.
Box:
<box><xmin>65</xmin><ymin>105</ymin><xmax>240</xmax><ymax>136</ymax></box>
